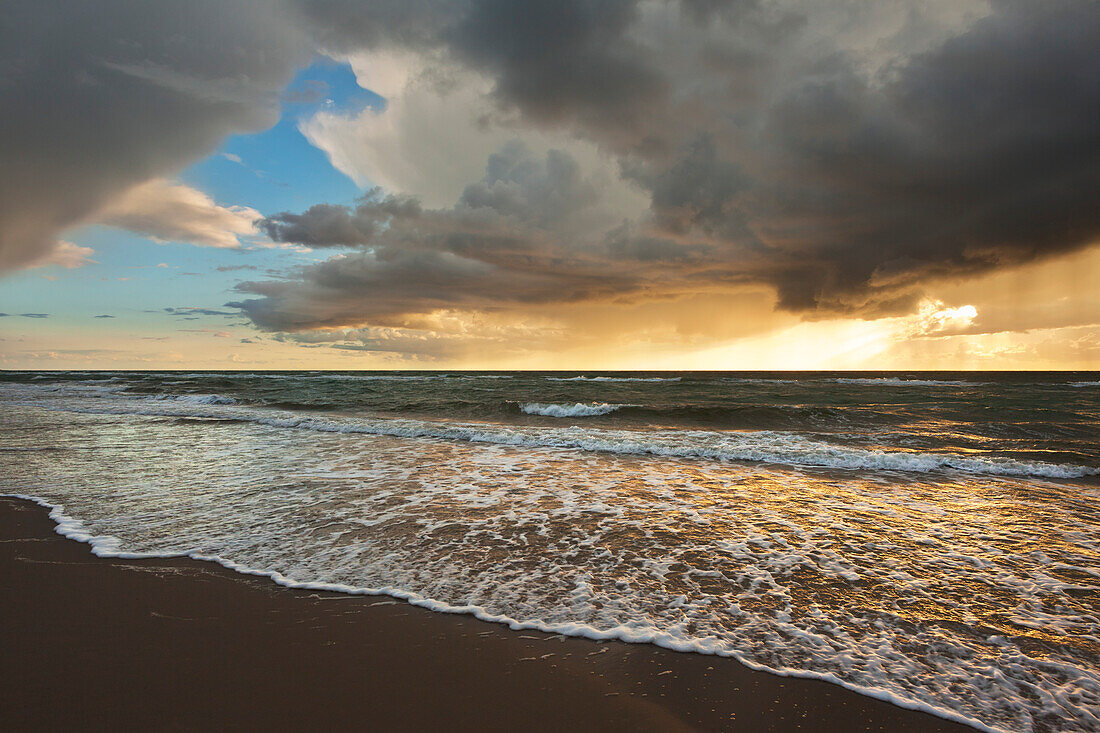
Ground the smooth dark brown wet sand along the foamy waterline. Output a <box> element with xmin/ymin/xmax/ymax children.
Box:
<box><xmin>0</xmin><ymin>499</ymin><xmax>972</xmax><ymax>732</ymax></box>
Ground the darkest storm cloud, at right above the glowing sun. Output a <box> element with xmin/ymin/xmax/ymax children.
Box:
<box><xmin>739</xmin><ymin>2</ymin><xmax>1100</xmax><ymax>310</ymax></box>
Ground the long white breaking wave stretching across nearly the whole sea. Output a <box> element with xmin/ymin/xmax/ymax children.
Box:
<box><xmin>15</xmin><ymin>400</ymin><xmax>1100</xmax><ymax>479</ymax></box>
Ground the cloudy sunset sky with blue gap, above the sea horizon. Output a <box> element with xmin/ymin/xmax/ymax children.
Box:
<box><xmin>0</xmin><ymin>0</ymin><xmax>1100</xmax><ymax>370</ymax></box>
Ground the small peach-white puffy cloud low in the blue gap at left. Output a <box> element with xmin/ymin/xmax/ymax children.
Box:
<box><xmin>96</xmin><ymin>178</ymin><xmax>261</xmax><ymax>249</ymax></box>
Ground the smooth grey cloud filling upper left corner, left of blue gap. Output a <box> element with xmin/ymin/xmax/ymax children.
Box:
<box><xmin>0</xmin><ymin>0</ymin><xmax>310</xmax><ymax>271</ymax></box>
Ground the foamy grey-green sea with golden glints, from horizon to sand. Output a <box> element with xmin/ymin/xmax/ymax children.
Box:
<box><xmin>0</xmin><ymin>371</ymin><xmax>1100</xmax><ymax>732</ymax></box>
